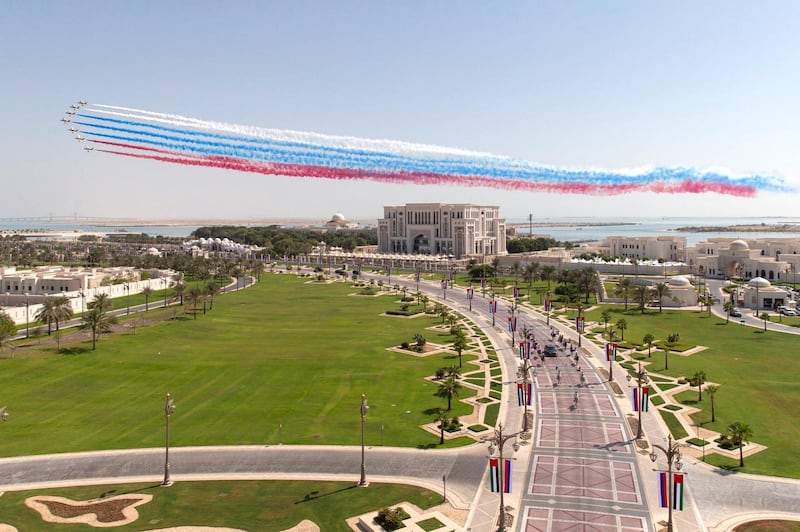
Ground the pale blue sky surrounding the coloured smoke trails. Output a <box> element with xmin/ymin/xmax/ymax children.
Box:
<box><xmin>0</xmin><ymin>1</ymin><xmax>800</xmax><ymax>219</ymax></box>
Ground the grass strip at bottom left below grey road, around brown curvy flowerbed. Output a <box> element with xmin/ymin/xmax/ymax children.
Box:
<box><xmin>0</xmin><ymin>481</ymin><xmax>441</xmax><ymax>532</ymax></box>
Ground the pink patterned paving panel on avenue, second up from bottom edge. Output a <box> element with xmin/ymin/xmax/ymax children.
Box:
<box><xmin>528</xmin><ymin>455</ymin><xmax>642</xmax><ymax>504</ymax></box>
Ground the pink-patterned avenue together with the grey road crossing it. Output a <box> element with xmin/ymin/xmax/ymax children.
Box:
<box><xmin>0</xmin><ymin>270</ymin><xmax>800</xmax><ymax>531</ymax></box>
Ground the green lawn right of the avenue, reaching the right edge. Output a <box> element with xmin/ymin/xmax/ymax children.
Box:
<box><xmin>586</xmin><ymin>306</ymin><xmax>800</xmax><ymax>478</ymax></box>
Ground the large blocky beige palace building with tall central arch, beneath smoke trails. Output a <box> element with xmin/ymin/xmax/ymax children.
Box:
<box><xmin>378</xmin><ymin>203</ymin><xmax>506</xmax><ymax>259</ymax></box>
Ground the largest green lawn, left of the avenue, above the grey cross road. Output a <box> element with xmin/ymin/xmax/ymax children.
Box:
<box><xmin>0</xmin><ymin>274</ymin><xmax>475</xmax><ymax>456</ymax></box>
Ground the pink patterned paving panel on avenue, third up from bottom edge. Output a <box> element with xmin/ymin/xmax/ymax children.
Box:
<box><xmin>536</xmin><ymin>419</ymin><xmax>631</xmax><ymax>454</ymax></box>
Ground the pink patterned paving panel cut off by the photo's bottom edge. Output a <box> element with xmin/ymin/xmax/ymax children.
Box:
<box><xmin>521</xmin><ymin>506</ymin><xmax>647</xmax><ymax>532</ymax></box>
